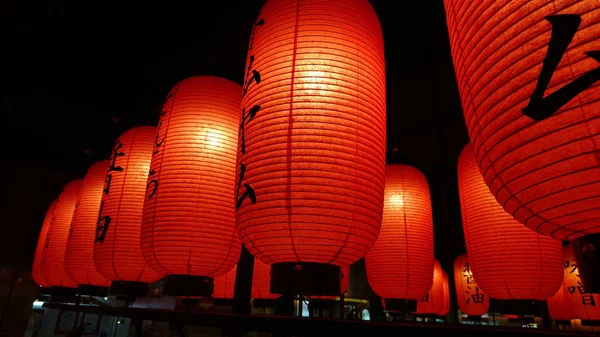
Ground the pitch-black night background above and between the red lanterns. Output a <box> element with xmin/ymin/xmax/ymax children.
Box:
<box><xmin>0</xmin><ymin>0</ymin><xmax>468</xmax><ymax>270</ymax></box>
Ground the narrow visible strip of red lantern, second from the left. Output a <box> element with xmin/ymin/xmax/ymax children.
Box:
<box><xmin>40</xmin><ymin>179</ymin><xmax>82</xmax><ymax>288</ymax></box>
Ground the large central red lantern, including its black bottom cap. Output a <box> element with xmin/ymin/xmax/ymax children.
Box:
<box><xmin>236</xmin><ymin>0</ymin><xmax>386</xmax><ymax>295</ymax></box>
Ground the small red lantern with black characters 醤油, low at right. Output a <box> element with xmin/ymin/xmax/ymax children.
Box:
<box><xmin>454</xmin><ymin>254</ymin><xmax>490</xmax><ymax>316</ymax></box>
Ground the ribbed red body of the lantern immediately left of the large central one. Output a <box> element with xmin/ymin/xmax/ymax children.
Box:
<box><xmin>141</xmin><ymin>76</ymin><xmax>242</xmax><ymax>277</ymax></box>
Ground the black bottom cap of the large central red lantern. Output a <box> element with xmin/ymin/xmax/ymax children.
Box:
<box><xmin>271</xmin><ymin>262</ymin><xmax>341</xmax><ymax>296</ymax></box>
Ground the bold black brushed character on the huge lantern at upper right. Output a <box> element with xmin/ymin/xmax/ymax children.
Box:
<box><xmin>522</xmin><ymin>14</ymin><xmax>600</xmax><ymax>121</ymax></box>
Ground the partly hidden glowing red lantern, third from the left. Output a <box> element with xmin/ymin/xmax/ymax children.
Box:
<box><xmin>65</xmin><ymin>160</ymin><xmax>110</xmax><ymax>286</ymax></box>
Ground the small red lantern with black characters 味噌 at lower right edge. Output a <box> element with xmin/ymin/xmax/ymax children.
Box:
<box><xmin>562</xmin><ymin>245</ymin><xmax>600</xmax><ymax>321</ymax></box>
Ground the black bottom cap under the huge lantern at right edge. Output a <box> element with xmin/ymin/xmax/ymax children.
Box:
<box><xmin>571</xmin><ymin>233</ymin><xmax>600</xmax><ymax>294</ymax></box>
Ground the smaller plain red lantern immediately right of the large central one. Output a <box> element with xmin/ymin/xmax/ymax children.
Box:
<box><xmin>365</xmin><ymin>164</ymin><xmax>434</xmax><ymax>300</ymax></box>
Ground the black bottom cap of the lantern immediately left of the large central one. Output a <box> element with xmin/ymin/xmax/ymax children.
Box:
<box><xmin>162</xmin><ymin>274</ymin><xmax>214</xmax><ymax>297</ymax></box>
